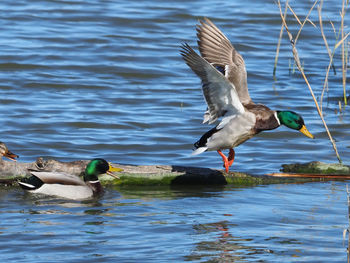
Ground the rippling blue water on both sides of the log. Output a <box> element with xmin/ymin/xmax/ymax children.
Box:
<box><xmin>0</xmin><ymin>0</ymin><xmax>350</xmax><ymax>262</ymax></box>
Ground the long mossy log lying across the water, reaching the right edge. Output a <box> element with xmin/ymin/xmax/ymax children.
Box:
<box><xmin>0</xmin><ymin>158</ymin><xmax>350</xmax><ymax>186</ymax></box>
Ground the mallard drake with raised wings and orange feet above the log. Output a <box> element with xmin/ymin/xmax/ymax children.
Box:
<box><xmin>180</xmin><ymin>18</ymin><xmax>314</xmax><ymax>172</ymax></box>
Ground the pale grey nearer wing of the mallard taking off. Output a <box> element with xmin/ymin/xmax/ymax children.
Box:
<box><xmin>181</xmin><ymin>44</ymin><xmax>244</xmax><ymax>124</ymax></box>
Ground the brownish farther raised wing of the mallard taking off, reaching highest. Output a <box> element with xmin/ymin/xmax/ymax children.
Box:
<box><xmin>197</xmin><ymin>18</ymin><xmax>251</xmax><ymax>104</ymax></box>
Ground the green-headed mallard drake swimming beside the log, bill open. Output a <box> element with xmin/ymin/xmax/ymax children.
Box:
<box><xmin>18</xmin><ymin>158</ymin><xmax>123</xmax><ymax>200</ymax></box>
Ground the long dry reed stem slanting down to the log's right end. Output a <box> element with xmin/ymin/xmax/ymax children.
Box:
<box><xmin>277</xmin><ymin>0</ymin><xmax>342</xmax><ymax>163</ymax></box>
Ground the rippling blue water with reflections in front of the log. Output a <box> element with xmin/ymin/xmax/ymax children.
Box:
<box><xmin>0</xmin><ymin>182</ymin><xmax>348</xmax><ymax>262</ymax></box>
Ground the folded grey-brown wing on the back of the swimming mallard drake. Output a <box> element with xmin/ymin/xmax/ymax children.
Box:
<box><xmin>30</xmin><ymin>171</ymin><xmax>86</xmax><ymax>186</ymax></box>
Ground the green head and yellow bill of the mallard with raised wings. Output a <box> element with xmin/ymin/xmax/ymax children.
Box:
<box><xmin>277</xmin><ymin>111</ymin><xmax>314</xmax><ymax>139</ymax></box>
